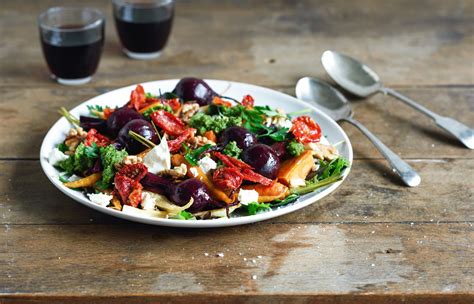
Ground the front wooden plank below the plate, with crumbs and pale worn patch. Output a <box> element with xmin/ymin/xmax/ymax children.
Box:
<box><xmin>0</xmin><ymin>223</ymin><xmax>474</xmax><ymax>300</ymax></box>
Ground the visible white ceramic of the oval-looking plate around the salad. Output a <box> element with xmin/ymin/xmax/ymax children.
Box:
<box><xmin>40</xmin><ymin>79</ymin><xmax>352</xmax><ymax>228</ymax></box>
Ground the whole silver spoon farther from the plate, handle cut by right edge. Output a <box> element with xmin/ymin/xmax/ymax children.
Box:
<box><xmin>321</xmin><ymin>51</ymin><xmax>474</xmax><ymax>149</ymax></box>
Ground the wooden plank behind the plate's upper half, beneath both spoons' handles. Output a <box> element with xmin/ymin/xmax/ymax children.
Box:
<box><xmin>0</xmin><ymin>87</ymin><xmax>474</xmax><ymax>159</ymax></box>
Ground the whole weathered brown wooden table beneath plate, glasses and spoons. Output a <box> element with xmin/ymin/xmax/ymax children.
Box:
<box><xmin>0</xmin><ymin>0</ymin><xmax>474</xmax><ymax>303</ymax></box>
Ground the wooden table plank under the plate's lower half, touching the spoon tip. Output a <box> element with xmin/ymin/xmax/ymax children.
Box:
<box><xmin>0</xmin><ymin>159</ymin><xmax>474</xmax><ymax>225</ymax></box>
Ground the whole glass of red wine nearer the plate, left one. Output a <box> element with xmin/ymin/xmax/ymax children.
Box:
<box><xmin>38</xmin><ymin>7</ymin><xmax>105</xmax><ymax>85</ymax></box>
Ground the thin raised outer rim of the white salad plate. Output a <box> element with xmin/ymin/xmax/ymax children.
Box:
<box><xmin>40</xmin><ymin>78</ymin><xmax>353</xmax><ymax>228</ymax></box>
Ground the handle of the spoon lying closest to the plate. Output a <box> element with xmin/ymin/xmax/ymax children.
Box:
<box><xmin>344</xmin><ymin>118</ymin><xmax>421</xmax><ymax>187</ymax></box>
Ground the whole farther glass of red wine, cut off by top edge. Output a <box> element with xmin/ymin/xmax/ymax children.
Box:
<box><xmin>112</xmin><ymin>0</ymin><xmax>174</xmax><ymax>59</ymax></box>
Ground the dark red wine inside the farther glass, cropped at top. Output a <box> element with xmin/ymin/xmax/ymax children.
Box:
<box><xmin>115</xmin><ymin>14</ymin><xmax>173</xmax><ymax>53</ymax></box>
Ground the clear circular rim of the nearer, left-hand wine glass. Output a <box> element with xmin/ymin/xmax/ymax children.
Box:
<box><xmin>37</xmin><ymin>6</ymin><xmax>105</xmax><ymax>32</ymax></box>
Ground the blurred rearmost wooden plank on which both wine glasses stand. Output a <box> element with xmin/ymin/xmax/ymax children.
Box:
<box><xmin>0</xmin><ymin>0</ymin><xmax>474</xmax><ymax>87</ymax></box>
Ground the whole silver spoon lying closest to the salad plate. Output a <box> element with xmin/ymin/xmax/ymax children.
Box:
<box><xmin>296</xmin><ymin>77</ymin><xmax>421</xmax><ymax>187</ymax></box>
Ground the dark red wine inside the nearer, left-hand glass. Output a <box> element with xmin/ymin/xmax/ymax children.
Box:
<box><xmin>41</xmin><ymin>26</ymin><xmax>104</xmax><ymax>79</ymax></box>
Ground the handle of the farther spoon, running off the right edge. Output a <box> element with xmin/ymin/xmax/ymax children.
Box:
<box><xmin>380</xmin><ymin>88</ymin><xmax>474</xmax><ymax>149</ymax></box>
